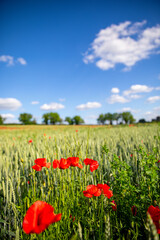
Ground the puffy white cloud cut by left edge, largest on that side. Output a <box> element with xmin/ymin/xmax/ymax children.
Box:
<box><xmin>0</xmin><ymin>98</ymin><xmax>22</xmax><ymax>111</ymax></box>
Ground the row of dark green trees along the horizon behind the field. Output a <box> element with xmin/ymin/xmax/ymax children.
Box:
<box><xmin>0</xmin><ymin>112</ymin><xmax>160</xmax><ymax>125</ymax></box>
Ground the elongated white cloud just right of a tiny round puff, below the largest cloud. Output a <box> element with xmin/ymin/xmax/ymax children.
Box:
<box><xmin>123</xmin><ymin>84</ymin><xmax>154</xmax><ymax>96</ymax></box>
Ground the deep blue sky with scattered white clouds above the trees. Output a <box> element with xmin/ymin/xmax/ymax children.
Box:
<box><xmin>0</xmin><ymin>0</ymin><xmax>160</xmax><ymax>124</ymax></box>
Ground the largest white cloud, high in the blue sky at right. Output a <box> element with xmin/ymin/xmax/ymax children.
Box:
<box><xmin>83</xmin><ymin>21</ymin><xmax>160</xmax><ymax>71</ymax></box>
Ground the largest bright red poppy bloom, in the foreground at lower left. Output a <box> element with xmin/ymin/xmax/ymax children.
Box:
<box><xmin>23</xmin><ymin>201</ymin><xmax>62</xmax><ymax>234</ymax></box>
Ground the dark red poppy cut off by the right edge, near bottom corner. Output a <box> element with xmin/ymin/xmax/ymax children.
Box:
<box><xmin>147</xmin><ymin>205</ymin><xmax>160</xmax><ymax>234</ymax></box>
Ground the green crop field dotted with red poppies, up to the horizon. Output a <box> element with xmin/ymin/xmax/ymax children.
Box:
<box><xmin>0</xmin><ymin>124</ymin><xmax>160</xmax><ymax>240</ymax></box>
